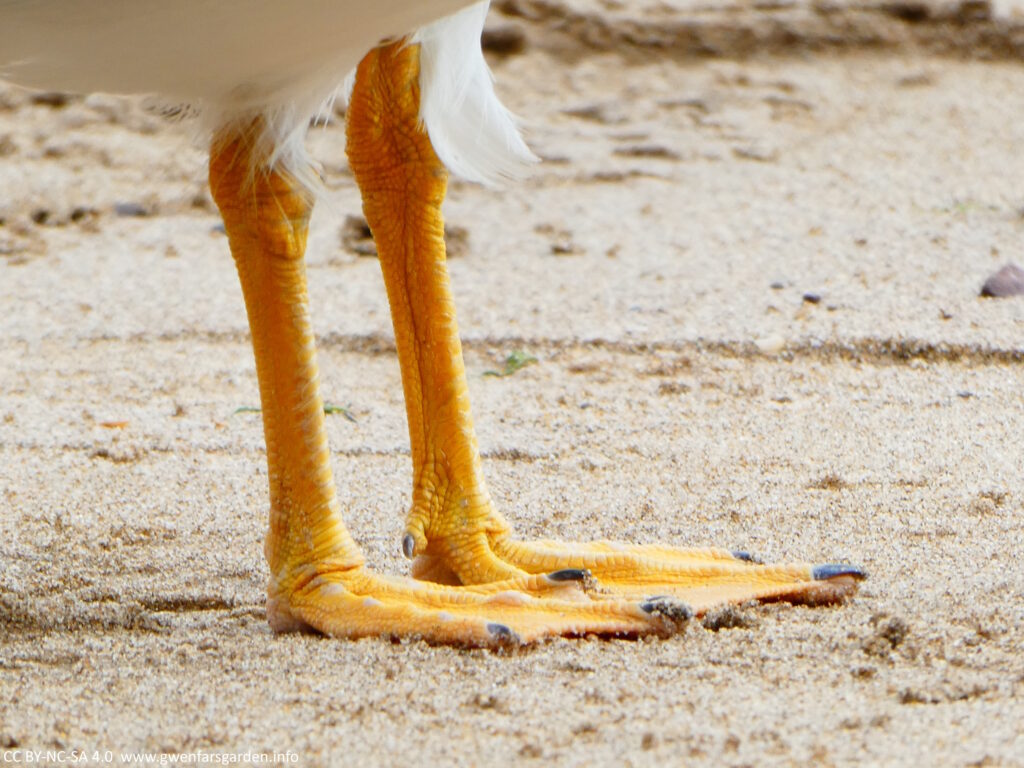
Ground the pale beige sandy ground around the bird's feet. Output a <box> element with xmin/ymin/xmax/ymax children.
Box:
<box><xmin>0</xmin><ymin>2</ymin><xmax>1024</xmax><ymax>766</ymax></box>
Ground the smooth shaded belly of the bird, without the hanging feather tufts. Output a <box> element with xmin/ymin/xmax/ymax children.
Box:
<box><xmin>0</xmin><ymin>0</ymin><xmax>472</xmax><ymax>110</ymax></box>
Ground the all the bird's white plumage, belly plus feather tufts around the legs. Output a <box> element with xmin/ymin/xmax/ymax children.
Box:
<box><xmin>0</xmin><ymin>0</ymin><xmax>532</xmax><ymax>182</ymax></box>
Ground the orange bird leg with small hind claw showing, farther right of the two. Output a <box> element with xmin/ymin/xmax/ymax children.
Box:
<box><xmin>347</xmin><ymin>43</ymin><xmax>864</xmax><ymax>612</ymax></box>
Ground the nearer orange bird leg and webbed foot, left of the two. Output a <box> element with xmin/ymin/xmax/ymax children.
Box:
<box><xmin>210</xmin><ymin>112</ymin><xmax>688</xmax><ymax>645</ymax></box>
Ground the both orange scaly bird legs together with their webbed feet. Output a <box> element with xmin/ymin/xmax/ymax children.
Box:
<box><xmin>210</xmin><ymin>37</ymin><xmax>863</xmax><ymax>646</ymax></box>
